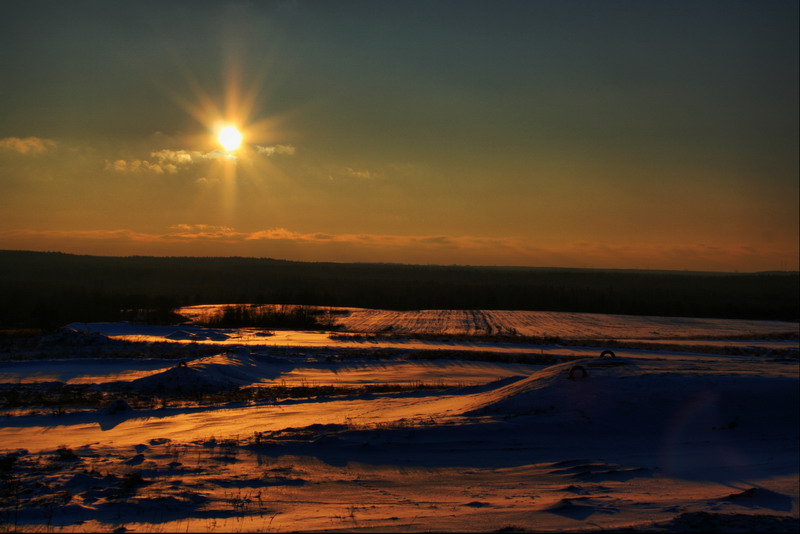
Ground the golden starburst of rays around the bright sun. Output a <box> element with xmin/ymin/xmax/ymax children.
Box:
<box><xmin>141</xmin><ymin>38</ymin><xmax>296</xmax><ymax>224</ymax></box>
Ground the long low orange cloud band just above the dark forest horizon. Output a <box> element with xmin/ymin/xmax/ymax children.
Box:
<box><xmin>0</xmin><ymin>228</ymin><xmax>798</xmax><ymax>271</ymax></box>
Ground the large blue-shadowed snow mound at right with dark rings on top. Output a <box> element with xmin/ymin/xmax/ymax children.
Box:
<box><xmin>463</xmin><ymin>358</ymin><xmax>800</xmax><ymax>450</ymax></box>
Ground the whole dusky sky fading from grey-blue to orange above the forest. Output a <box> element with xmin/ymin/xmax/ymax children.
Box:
<box><xmin>0</xmin><ymin>0</ymin><xmax>800</xmax><ymax>272</ymax></box>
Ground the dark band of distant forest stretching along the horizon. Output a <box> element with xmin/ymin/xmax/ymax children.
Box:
<box><xmin>0</xmin><ymin>251</ymin><xmax>800</xmax><ymax>329</ymax></box>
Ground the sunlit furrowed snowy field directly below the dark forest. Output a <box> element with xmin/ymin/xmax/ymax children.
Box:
<box><xmin>68</xmin><ymin>305</ymin><xmax>800</xmax><ymax>356</ymax></box>
